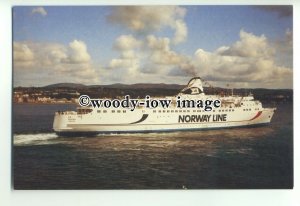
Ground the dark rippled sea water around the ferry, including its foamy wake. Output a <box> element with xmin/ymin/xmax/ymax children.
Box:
<box><xmin>12</xmin><ymin>103</ymin><xmax>293</xmax><ymax>189</ymax></box>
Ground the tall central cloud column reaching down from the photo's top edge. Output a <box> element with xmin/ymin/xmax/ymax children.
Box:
<box><xmin>107</xmin><ymin>6</ymin><xmax>188</xmax><ymax>80</ymax></box>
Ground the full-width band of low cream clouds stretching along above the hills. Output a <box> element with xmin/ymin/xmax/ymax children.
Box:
<box><xmin>13</xmin><ymin>26</ymin><xmax>293</xmax><ymax>88</ymax></box>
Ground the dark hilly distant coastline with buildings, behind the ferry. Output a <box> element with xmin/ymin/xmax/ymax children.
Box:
<box><xmin>13</xmin><ymin>83</ymin><xmax>293</xmax><ymax>104</ymax></box>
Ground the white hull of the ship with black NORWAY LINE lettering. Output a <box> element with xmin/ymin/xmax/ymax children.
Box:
<box><xmin>53</xmin><ymin>108</ymin><xmax>275</xmax><ymax>135</ymax></box>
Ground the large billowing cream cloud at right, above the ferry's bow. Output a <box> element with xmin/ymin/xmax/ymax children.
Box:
<box><xmin>187</xmin><ymin>30</ymin><xmax>293</xmax><ymax>88</ymax></box>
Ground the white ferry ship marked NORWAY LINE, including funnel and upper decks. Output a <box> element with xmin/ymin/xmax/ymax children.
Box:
<box><xmin>53</xmin><ymin>77</ymin><xmax>276</xmax><ymax>136</ymax></box>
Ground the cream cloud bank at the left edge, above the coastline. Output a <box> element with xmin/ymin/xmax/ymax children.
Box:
<box><xmin>13</xmin><ymin>40</ymin><xmax>99</xmax><ymax>85</ymax></box>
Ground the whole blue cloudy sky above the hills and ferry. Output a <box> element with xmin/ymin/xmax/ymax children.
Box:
<box><xmin>13</xmin><ymin>5</ymin><xmax>293</xmax><ymax>89</ymax></box>
